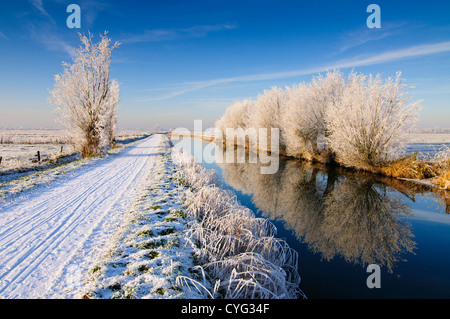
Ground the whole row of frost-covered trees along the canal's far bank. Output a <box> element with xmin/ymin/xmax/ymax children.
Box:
<box><xmin>216</xmin><ymin>70</ymin><xmax>421</xmax><ymax>169</ymax></box>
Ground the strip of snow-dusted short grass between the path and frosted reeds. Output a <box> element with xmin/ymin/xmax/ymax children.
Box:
<box><xmin>78</xmin><ymin>150</ymin><xmax>201</xmax><ymax>299</ymax></box>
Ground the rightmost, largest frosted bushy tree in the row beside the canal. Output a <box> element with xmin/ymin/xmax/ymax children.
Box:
<box><xmin>325</xmin><ymin>73</ymin><xmax>420</xmax><ymax>169</ymax></box>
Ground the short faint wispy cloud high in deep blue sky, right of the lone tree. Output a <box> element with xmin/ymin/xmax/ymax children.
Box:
<box><xmin>120</xmin><ymin>24</ymin><xmax>236</xmax><ymax>43</ymax></box>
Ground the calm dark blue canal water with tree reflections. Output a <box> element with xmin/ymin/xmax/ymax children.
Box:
<box><xmin>173</xmin><ymin>138</ymin><xmax>450</xmax><ymax>299</ymax></box>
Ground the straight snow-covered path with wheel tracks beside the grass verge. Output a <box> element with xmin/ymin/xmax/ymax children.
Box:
<box><xmin>0</xmin><ymin>134</ymin><xmax>167</xmax><ymax>298</ymax></box>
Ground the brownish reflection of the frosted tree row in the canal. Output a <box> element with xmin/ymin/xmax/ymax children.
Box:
<box><xmin>216</xmin><ymin>149</ymin><xmax>416</xmax><ymax>272</ymax></box>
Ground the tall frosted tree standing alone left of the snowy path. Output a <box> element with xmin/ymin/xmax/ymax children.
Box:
<box><xmin>49</xmin><ymin>32</ymin><xmax>119</xmax><ymax>157</ymax></box>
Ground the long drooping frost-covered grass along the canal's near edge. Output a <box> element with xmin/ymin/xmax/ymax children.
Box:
<box><xmin>173</xmin><ymin>153</ymin><xmax>305</xmax><ymax>299</ymax></box>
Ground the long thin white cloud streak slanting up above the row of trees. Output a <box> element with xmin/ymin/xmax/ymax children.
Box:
<box><xmin>146</xmin><ymin>41</ymin><xmax>450</xmax><ymax>101</ymax></box>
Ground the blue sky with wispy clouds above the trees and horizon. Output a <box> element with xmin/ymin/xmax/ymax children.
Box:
<box><xmin>0</xmin><ymin>0</ymin><xmax>450</xmax><ymax>129</ymax></box>
